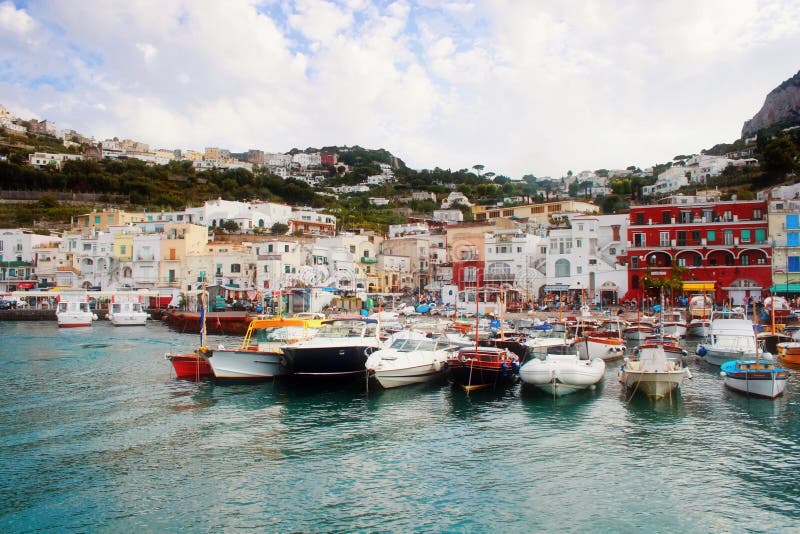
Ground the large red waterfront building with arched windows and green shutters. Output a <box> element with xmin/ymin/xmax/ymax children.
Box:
<box><xmin>626</xmin><ymin>197</ymin><xmax>772</xmax><ymax>304</ymax></box>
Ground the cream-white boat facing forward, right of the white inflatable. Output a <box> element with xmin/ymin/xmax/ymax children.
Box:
<box><xmin>619</xmin><ymin>344</ymin><xmax>691</xmax><ymax>399</ymax></box>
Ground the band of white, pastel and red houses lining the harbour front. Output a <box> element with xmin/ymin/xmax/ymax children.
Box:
<box><xmin>0</xmin><ymin>186</ymin><xmax>800</xmax><ymax>309</ymax></box>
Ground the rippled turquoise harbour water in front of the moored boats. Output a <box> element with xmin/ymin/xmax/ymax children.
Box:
<box><xmin>0</xmin><ymin>323</ymin><xmax>800</xmax><ymax>532</ymax></box>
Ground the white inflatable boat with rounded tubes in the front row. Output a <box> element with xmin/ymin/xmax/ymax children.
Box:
<box><xmin>519</xmin><ymin>352</ymin><xmax>606</xmax><ymax>397</ymax></box>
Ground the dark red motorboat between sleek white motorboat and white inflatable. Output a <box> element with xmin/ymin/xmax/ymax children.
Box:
<box><xmin>447</xmin><ymin>347</ymin><xmax>519</xmax><ymax>391</ymax></box>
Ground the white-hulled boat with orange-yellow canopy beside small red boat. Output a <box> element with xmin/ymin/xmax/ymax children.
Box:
<box><xmin>208</xmin><ymin>317</ymin><xmax>318</xmax><ymax>380</ymax></box>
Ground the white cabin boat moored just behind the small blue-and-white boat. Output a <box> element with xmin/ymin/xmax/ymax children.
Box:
<box><xmin>696</xmin><ymin>312</ymin><xmax>772</xmax><ymax>365</ymax></box>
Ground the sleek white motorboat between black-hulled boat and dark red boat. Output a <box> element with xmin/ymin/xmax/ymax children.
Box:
<box><xmin>366</xmin><ymin>331</ymin><xmax>450</xmax><ymax>389</ymax></box>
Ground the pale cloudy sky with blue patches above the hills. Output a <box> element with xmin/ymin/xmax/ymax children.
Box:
<box><xmin>0</xmin><ymin>0</ymin><xmax>800</xmax><ymax>178</ymax></box>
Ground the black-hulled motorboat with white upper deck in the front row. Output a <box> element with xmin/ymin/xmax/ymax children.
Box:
<box><xmin>281</xmin><ymin>317</ymin><xmax>382</xmax><ymax>378</ymax></box>
